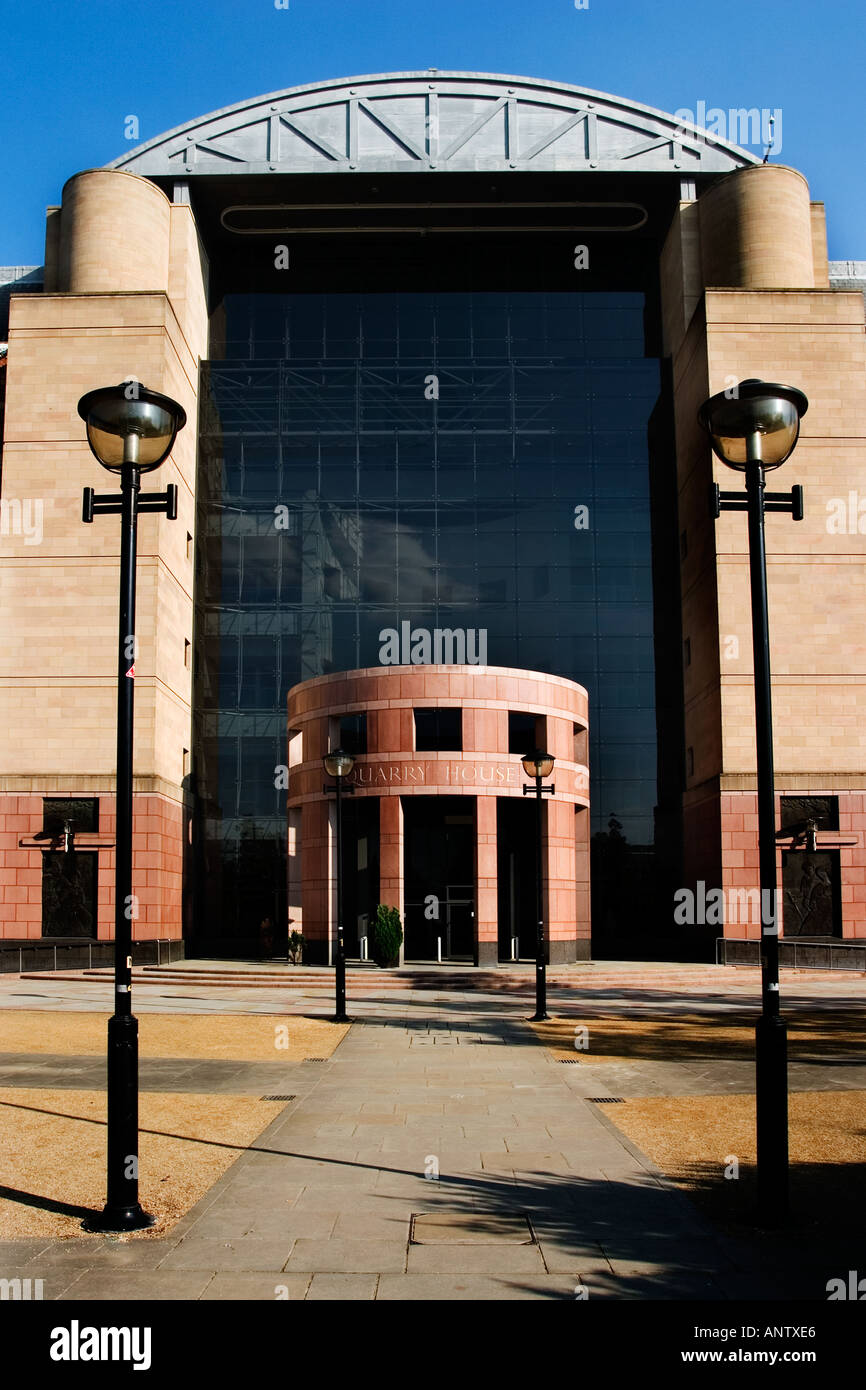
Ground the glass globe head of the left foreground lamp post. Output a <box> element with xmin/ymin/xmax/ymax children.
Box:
<box><xmin>78</xmin><ymin>379</ymin><xmax>186</xmax><ymax>473</ymax></box>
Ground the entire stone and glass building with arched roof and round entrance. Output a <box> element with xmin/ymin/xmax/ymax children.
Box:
<box><xmin>0</xmin><ymin>71</ymin><xmax>866</xmax><ymax>963</ymax></box>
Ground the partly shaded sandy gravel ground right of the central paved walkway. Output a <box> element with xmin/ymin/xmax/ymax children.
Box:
<box><xmin>531</xmin><ymin>1005</ymin><xmax>866</xmax><ymax>1241</ymax></box>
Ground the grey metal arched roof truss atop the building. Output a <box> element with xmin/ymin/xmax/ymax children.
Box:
<box><xmin>107</xmin><ymin>68</ymin><xmax>758</xmax><ymax>179</ymax></box>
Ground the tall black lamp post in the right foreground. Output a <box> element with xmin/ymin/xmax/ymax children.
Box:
<box><xmin>698</xmin><ymin>379</ymin><xmax>809</xmax><ymax>1225</ymax></box>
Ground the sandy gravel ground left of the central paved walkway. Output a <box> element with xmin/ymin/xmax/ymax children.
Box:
<box><xmin>0</xmin><ymin>1009</ymin><xmax>348</xmax><ymax>1240</ymax></box>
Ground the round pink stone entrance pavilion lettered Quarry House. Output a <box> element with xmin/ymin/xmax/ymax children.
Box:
<box><xmin>288</xmin><ymin>663</ymin><xmax>591</xmax><ymax>965</ymax></box>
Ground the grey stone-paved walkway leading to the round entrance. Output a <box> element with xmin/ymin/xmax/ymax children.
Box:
<box><xmin>0</xmin><ymin>995</ymin><xmax>817</xmax><ymax>1300</ymax></box>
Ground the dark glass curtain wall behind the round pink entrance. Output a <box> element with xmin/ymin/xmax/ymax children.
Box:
<box><xmin>196</xmin><ymin>292</ymin><xmax>660</xmax><ymax>937</ymax></box>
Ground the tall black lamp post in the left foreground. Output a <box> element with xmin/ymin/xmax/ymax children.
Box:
<box><xmin>78</xmin><ymin>381</ymin><xmax>186</xmax><ymax>1230</ymax></box>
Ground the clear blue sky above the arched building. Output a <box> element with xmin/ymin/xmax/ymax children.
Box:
<box><xmin>0</xmin><ymin>0</ymin><xmax>866</xmax><ymax>265</ymax></box>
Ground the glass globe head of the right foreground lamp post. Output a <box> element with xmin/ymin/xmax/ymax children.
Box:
<box><xmin>698</xmin><ymin>377</ymin><xmax>809</xmax><ymax>473</ymax></box>
